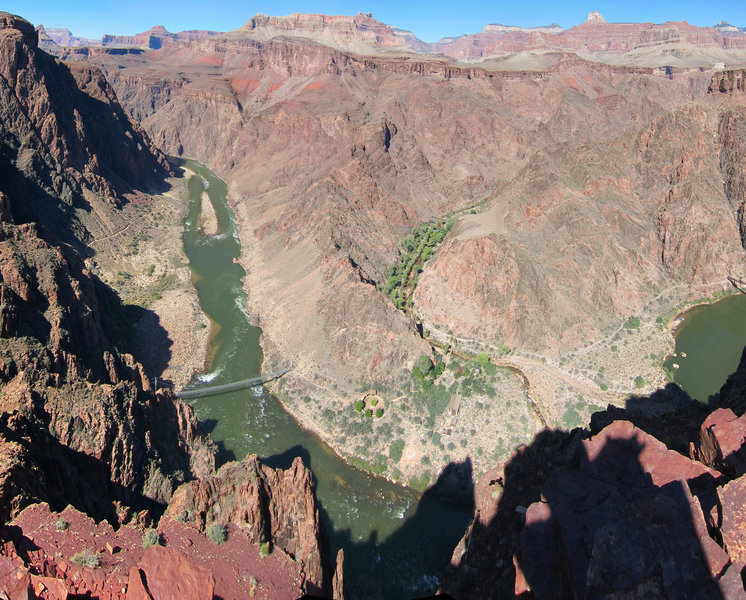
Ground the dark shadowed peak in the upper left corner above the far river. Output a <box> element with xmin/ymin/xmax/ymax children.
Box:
<box><xmin>0</xmin><ymin>13</ymin><xmax>169</xmax><ymax>216</ymax></box>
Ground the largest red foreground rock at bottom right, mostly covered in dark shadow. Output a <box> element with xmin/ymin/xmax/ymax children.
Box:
<box><xmin>519</xmin><ymin>421</ymin><xmax>729</xmax><ymax>599</ymax></box>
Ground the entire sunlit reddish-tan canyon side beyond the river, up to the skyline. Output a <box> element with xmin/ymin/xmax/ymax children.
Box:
<box><xmin>55</xmin><ymin>10</ymin><xmax>743</xmax><ymax>485</ymax></box>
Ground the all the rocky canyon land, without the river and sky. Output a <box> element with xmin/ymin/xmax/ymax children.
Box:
<box><xmin>0</xmin><ymin>5</ymin><xmax>746</xmax><ymax>598</ymax></box>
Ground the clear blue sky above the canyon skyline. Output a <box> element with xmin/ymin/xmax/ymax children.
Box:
<box><xmin>2</xmin><ymin>0</ymin><xmax>746</xmax><ymax>42</ymax></box>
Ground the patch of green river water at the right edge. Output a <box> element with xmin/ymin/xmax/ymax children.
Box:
<box><xmin>665</xmin><ymin>294</ymin><xmax>746</xmax><ymax>402</ymax></box>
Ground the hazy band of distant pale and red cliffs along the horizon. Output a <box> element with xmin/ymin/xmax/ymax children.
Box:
<box><xmin>42</xmin><ymin>11</ymin><xmax>746</xmax><ymax>62</ymax></box>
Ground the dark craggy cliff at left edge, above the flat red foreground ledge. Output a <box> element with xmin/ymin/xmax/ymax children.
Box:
<box><xmin>0</xmin><ymin>15</ymin><xmax>216</xmax><ymax>519</ymax></box>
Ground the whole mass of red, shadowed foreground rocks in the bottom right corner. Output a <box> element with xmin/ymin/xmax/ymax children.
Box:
<box><xmin>441</xmin><ymin>353</ymin><xmax>746</xmax><ymax>600</ymax></box>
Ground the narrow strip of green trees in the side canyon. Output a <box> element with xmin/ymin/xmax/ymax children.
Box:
<box><xmin>380</xmin><ymin>219</ymin><xmax>453</xmax><ymax>310</ymax></box>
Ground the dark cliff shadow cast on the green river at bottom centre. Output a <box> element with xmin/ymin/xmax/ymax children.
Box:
<box><xmin>262</xmin><ymin>446</ymin><xmax>474</xmax><ymax>600</ymax></box>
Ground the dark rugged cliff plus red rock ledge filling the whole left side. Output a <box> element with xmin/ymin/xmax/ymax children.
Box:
<box><xmin>0</xmin><ymin>15</ymin><xmax>329</xmax><ymax>598</ymax></box>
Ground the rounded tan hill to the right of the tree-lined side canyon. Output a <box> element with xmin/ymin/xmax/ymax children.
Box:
<box><xmin>415</xmin><ymin>98</ymin><xmax>744</xmax><ymax>354</ymax></box>
